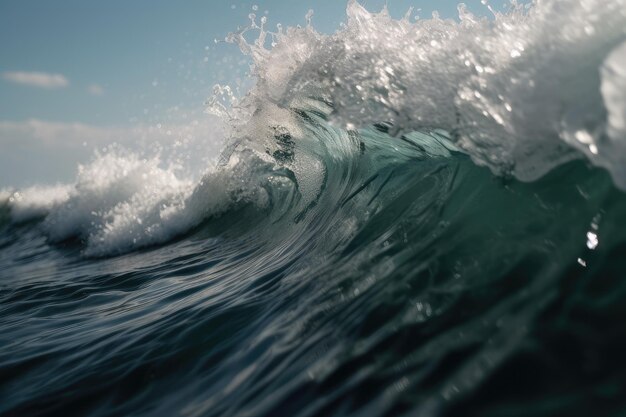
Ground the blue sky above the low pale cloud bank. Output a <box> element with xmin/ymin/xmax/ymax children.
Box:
<box><xmin>0</xmin><ymin>0</ymin><xmax>520</xmax><ymax>187</ymax></box>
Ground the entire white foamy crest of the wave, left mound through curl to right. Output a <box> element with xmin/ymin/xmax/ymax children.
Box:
<box><xmin>0</xmin><ymin>0</ymin><xmax>626</xmax><ymax>256</ymax></box>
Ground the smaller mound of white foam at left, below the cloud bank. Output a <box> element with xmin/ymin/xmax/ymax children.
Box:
<box><xmin>0</xmin><ymin>142</ymin><xmax>280</xmax><ymax>256</ymax></box>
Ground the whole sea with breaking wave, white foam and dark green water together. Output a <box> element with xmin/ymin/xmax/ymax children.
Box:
<box><xmin>0</xmin><ymin>0</ymin><xmax>626</xmax><ymax>416</ymax></box>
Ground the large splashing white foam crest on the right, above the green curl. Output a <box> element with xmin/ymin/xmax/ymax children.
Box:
<box><xmin>218</xmin><ymin>0</ymin><xmax>626</xmax><ymax>188</ymax></box>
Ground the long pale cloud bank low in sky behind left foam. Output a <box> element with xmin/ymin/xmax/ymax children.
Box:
<box><xmin>0</xmin><ymin>115</ymin><xmax>224</xmax><ymax>189</ymax></box>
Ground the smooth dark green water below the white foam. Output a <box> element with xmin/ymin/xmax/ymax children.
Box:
<box><xmin>0</xmin><ymin>105</ymin><xmax>626</xmax><ymax>416</ymax></box>
